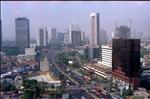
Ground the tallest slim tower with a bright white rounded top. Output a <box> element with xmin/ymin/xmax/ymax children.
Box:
<box><xmin>90</xmin><ymin>13</ymin><xmax>101</xmax><ymax>46</ymax></box>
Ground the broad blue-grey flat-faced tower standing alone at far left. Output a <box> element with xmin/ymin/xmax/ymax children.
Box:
<box><xmin>15</xmin><ymin>17</ymin><xmax>30</xmax><ymax>49</ymax></box>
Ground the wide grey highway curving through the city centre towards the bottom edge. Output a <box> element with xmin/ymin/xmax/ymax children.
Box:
<box><xmin>47</xmin><ymin>51</ymin><xmax>104</xmax><ymax>99</ymax></box>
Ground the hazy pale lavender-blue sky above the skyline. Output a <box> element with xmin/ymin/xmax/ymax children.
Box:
<box><xmin>1</xmin><ymin>1</ymin><xmax>150</xmax><ymax>40</ymax></box>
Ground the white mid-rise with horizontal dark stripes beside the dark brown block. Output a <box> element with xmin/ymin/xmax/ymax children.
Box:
<box><xmin>101</xmin><ymin>45</ymin><xmax>112</xmax><ymax>67</ymax></box>
